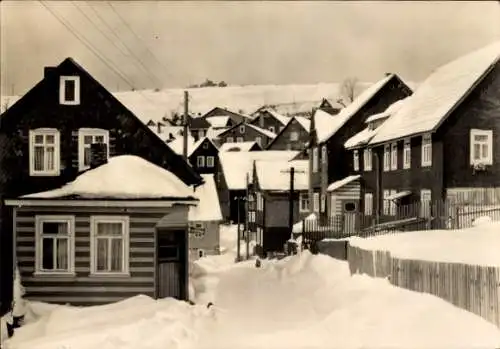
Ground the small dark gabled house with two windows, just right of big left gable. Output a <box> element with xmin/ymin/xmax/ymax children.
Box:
<box><xmin>188</xmin><ymin>137</ymin><xmax>219</xmax><ymax>174</ymax></box>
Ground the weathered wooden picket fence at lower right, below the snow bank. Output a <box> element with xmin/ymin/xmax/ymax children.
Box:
<box><xmin>347</xmin><ymin>245</ymin><xmax>500</xmax><ymax>328</ymax></box>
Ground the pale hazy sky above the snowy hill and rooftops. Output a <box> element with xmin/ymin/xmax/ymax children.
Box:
<box><xmin>0</xmin><ymin>0</ymin><xmax>500</xmax><ymax>95</ymax></box>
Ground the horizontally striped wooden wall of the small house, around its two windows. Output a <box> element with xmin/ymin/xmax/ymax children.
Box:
<box><xmin>15</xmin><ymin>206</ymin><xmax>187</xmax><ymax>305</ymax></box>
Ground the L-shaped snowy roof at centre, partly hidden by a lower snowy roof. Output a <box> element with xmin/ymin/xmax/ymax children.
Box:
<box><xmin>219</xmin><ymin>150</ymin><xmax>298</xmax><ymax>190</ymax></box>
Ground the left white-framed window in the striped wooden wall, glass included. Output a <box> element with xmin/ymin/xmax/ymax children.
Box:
<box><xmin>35</xmin><ymin>216</ymin><xmax>75</xmax><ymax>274</ymax></box>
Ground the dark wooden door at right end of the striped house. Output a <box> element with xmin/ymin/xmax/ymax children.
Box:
<box><xmin>156</xmin><ymin>229</ymin><xmax>187</xmax><ymax>299</ymax></box>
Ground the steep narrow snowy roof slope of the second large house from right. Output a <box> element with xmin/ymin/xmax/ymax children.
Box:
<box><xmin>315</xmin><ymin>74</ymin><xmax>394</xmax><ymax>143</ymax></box>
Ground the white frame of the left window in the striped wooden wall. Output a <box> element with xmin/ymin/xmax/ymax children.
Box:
<box><xmin>35</xmin><ymin>215</ymin><xmax>75</xmax><ymax>275</ymax></box>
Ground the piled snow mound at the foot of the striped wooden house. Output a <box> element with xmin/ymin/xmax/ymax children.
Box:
<box><xmin>5</xmin><ymin>296</ymin><xmax>215</xmax><ymax>349</ymax></box>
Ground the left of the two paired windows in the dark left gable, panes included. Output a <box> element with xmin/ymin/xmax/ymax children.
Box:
<box><xmin>29</xmin><ymin>128</ymin><xmax>60</xmax><ymax>176</ymax></box>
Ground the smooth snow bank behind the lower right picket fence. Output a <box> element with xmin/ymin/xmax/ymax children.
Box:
<box><xmin>350</xmin><ymin>222</ymin><xmax>500</xmax><ymax>266</ymax></box>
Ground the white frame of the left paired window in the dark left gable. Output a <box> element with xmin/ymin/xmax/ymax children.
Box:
<box><xmin>29</xmin><ymin>128</ymin><xmax>61</xmax><ymax>176</ymax></box>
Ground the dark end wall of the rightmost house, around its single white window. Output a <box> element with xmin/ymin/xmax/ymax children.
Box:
<box><xmin>437</xmin><ymin>62</ymin><xmax>500</xmax><ymax>188</ymax></box>
